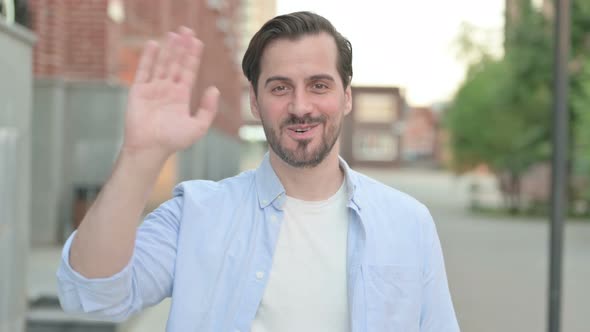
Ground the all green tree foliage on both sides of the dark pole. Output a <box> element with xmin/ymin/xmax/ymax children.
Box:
<box><xmin>445</xmin><ymin>0</ymin><xmax>590</xmax><ymax>210</ymax></box>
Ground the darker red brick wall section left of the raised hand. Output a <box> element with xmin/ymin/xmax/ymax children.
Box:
<box><xmin>30</xmin><ymin>0</ymin><xmax>118</xmax><ymax>80</ymax></box>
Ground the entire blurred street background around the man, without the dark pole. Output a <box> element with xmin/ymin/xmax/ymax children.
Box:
<box><xmin>0</xmin><ymin>0</ymin><xmax>590</xmax><ymax>332</ymax></box>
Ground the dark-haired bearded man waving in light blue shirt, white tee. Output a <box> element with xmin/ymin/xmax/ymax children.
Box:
<box><xmin>58</xmin><ymin>12</ymin><xmax>459</xmax><ymax>332</ymax></box>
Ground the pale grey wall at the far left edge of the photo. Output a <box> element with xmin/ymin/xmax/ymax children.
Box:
<box><xmin>0</xmin><ymin>20</ymin><xmax>34</xmax><ymax>332</ymax></box>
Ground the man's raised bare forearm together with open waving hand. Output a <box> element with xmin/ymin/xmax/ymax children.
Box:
<box><xmin>69</xmin><ymin>28</ymin><xmax>219</xmax><ymax>278</ymax></box>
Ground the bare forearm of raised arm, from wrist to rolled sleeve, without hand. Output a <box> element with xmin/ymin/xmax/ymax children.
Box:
<box><xmin>70</xmin><ymin>149</ymin><xmax>166</xmax><ymax>278</ymax></box>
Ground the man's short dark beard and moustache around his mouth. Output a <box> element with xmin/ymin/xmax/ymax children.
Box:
<box><xmin>261</xmin><ymin>114</ymin><xmax>342</xmax><ymax>168</ymax></box>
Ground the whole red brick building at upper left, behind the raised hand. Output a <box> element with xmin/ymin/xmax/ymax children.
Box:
<box><xmin>30</xmin><ymin>0</ymin><xmax>242</xmax><ymax>137</ymax></box>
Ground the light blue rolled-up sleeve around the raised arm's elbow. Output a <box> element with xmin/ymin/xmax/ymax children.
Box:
<box><xmin>57</xmin><ymin>196</ymin><xmax>182</xmax><ymax>321</ymax></box>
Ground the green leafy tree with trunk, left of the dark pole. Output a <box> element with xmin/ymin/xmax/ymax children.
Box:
<box><xmin>446</xmin><ymin>1</ymin><xmax>551</xmax><ymax>211</ymax></box>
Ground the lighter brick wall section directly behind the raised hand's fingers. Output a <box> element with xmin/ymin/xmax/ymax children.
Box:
<box><xmin>117</xmin><ymin>0</ymin><xmax>242</xmax><ymax>137</ymax></box>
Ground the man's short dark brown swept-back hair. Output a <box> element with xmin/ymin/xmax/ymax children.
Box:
<box><xmin>242</xmin><ymin>12</ymin><xmax>352</xmax><ymax>93</ymax></box>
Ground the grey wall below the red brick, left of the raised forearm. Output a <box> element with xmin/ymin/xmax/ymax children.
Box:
<box><xmin>31</xmin><ymin>79</ymin><xmax>127</xmax><ymax>247</ymax></box>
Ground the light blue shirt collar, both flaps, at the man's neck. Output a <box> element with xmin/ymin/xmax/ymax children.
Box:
<box><xmin>255</xmin><ymin>152</ymin><xmax>360</xmax><ymax>210</ymax></box>
